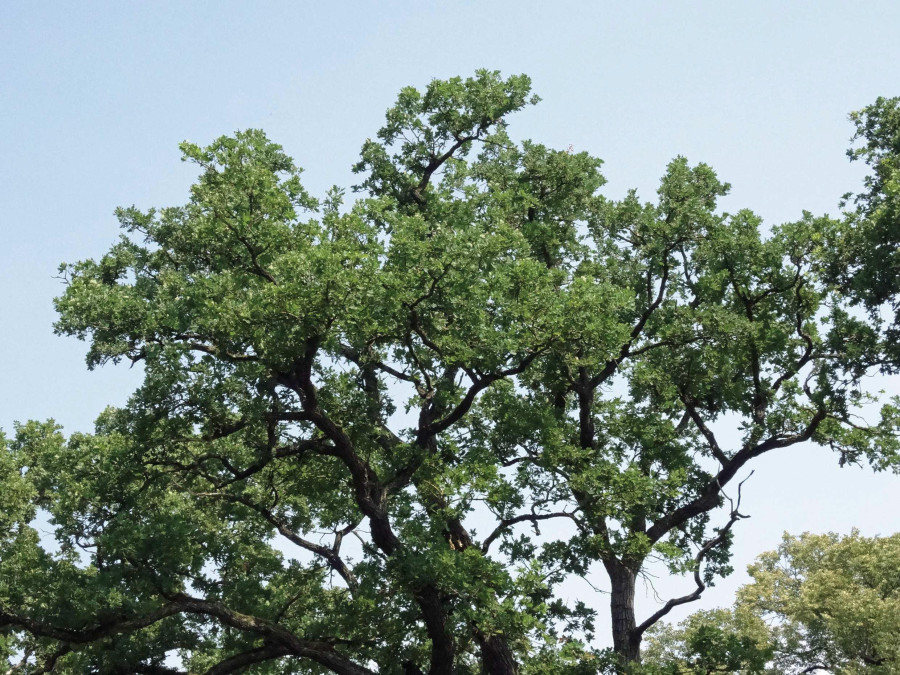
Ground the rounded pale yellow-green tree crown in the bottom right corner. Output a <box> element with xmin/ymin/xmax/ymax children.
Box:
<box><xmin>739</xmin><ymin>532</ymin><xmax>900</xmax><ymax>675</ymax></box>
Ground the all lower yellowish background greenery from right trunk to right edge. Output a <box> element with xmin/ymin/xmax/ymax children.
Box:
<box><xmin>646</xmin><ymin>532</ymin><xmax>900</xmax><ymax>675</ymax></box>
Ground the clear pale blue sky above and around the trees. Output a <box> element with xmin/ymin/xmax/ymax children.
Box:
<box><xmin>0</xmin><ymin>0</ymin><xmax>900</xmax><ymax>644</ymax></box>
